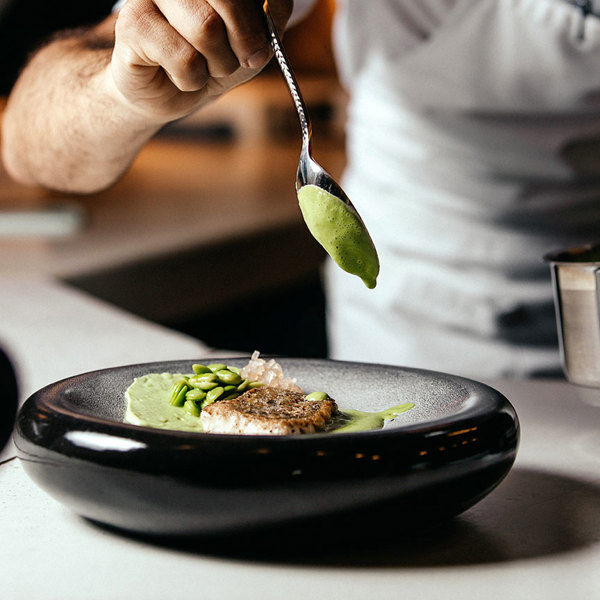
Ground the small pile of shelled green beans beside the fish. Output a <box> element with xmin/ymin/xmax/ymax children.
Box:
<box><xmin>169</xmin><ymin>363</ymin><xmax>264</xmax><ymax>417</ymax></box>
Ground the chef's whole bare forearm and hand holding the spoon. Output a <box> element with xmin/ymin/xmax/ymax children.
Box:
<box><xmin>2</xmin><ymin>0</ymin><xmax>312</xmax><ymax>193</ymax></box>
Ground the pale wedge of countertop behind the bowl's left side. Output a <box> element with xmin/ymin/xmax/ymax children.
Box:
<box><xmin>0</xmin><ymin>275</ymin><xmax>230</xmax><ymax>462</ymax></box>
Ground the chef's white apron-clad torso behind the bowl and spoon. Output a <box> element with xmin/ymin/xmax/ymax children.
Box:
<box><xmin>326</xmin><ymin>0</ymin><xmax>600</xmax><ymax>378</ymax></box>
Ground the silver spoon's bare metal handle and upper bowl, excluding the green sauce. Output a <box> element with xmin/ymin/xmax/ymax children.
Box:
<box><xmin>264</xmin><ymin>2</ymin><xmax>360</xmax><ymax>212</ymax></box>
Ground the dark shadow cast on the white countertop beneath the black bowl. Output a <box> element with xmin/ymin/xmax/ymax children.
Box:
<box><xmin>88</xmin><ymin>468</ymin><xmax>600</xmax><ymax>569</ymax></box>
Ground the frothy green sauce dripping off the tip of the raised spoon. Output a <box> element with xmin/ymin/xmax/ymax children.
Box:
<box><xmin>298</xmin><ymin>185</ymin><xmax>379</xmax><ymax>289</ymax></box>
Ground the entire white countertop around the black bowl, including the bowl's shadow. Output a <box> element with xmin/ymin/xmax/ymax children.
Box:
<box><xmin>0</xmin><ymin>277</ymin><xmax>600</xmax><ymax>600</ymax></box>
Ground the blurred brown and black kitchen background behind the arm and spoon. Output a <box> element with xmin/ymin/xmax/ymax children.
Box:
<box><xmin>0</xmin><ymin>0</ymin><xmax>346</xmax><ymax>357</ymax></box>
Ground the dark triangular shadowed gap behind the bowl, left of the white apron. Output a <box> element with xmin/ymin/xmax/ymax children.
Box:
<box><xmin>65</xmin><ymin>223</ymin><xmax>327</xmax><ymax>358</ymax></box>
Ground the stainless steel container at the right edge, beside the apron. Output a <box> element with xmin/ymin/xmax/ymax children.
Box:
<box><xmin>545</xmin><ymin>243</ymin><xmax>600</xmax><ymax>388</ymax></box>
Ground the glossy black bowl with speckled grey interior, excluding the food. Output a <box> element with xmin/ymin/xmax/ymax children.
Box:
<box><xmin>15</xmin><ymin>358</ymin><xmax>519</xmax><ymax>536</ymax></box>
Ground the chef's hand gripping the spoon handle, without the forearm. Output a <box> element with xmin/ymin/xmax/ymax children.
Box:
<box><xmin>107</xmin><ymin>0</ymin><xmax>293</xmax><ymax>123</ymax></box>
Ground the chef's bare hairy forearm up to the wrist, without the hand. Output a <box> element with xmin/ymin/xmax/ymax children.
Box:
<box><xmin>2</xmin><ymin>18</ymin><xmax>161</xmax><ymax>193</ymax></box>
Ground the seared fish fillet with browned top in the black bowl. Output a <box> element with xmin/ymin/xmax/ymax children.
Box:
<box><xmin>200</xmin><ymin>386</ymin><xmax>337</xmax><ymax>435</ymax></box>
